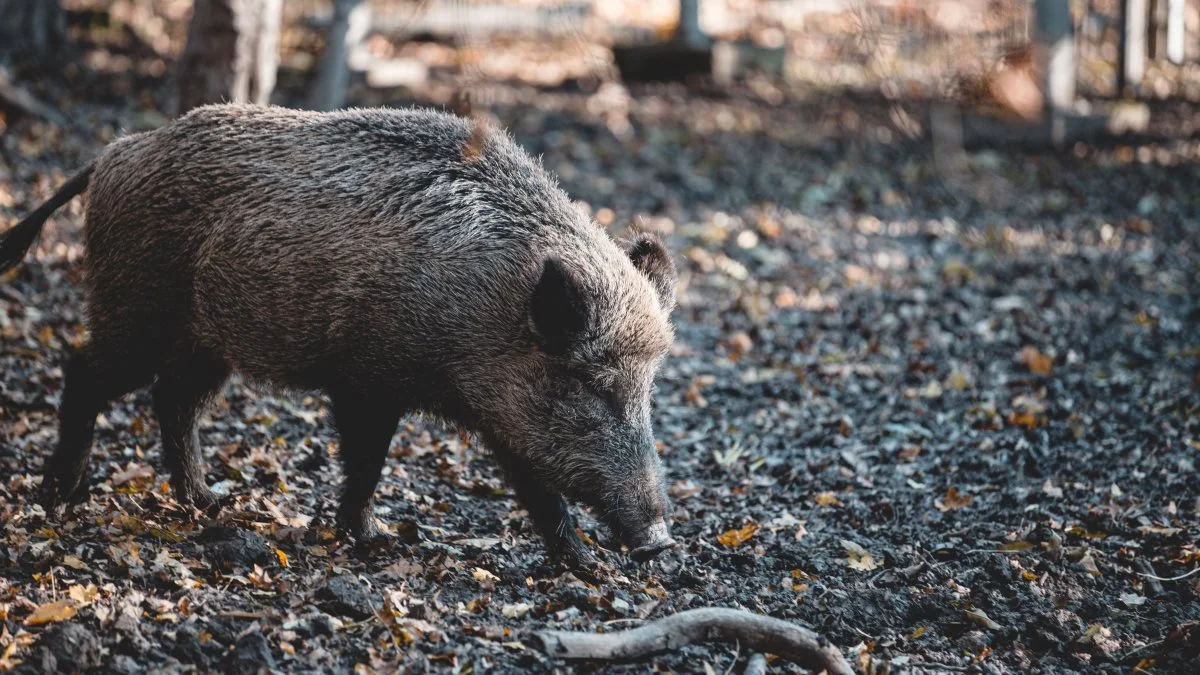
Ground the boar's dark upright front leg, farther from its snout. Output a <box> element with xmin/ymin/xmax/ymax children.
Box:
<box><xmin>330</xmin><ymin>392</ymin><xmax>402</xmax><ymax>543</ymax></box>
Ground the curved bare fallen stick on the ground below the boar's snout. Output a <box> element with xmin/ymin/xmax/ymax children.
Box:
<box><xmin>534</xmin><ymin>607</ymin><xmax>854</xmax><ymax>675</ymax></box>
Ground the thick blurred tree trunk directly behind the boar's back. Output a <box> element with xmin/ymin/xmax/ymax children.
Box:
<box><xmin>175</xmin><ymin>0</ymin><xmax>282</xmax><ymax>114</ymax></box>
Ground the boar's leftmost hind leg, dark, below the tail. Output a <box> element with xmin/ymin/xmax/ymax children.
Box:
<box><xmin>42</xmin><ymin>335</ymin><xmax>154</xmax><ymax>510</ymax></box>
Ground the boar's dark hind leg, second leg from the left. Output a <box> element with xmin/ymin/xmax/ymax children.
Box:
<box><xmin>154</xmin><ymin>352</ymin><xmax>229</xmax><ymax>510</ymax></box>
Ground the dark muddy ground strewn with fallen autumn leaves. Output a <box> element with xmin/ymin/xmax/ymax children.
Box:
<box><xmin>0</xmin><ymin>44</ymin><xmax>1200</xmax><ymax>673</ymax></box>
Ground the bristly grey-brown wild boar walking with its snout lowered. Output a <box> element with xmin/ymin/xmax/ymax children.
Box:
<box><xmin>0</xmin><ymin>104</ymin><xmax>676</xmax><ymax>565</ymax></box>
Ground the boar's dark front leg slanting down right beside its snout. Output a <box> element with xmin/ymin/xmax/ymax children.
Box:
<box><xmin>497</xmin><ymin>453</ymin><xmax>598</xmax><ymax>569</ymax></box>
